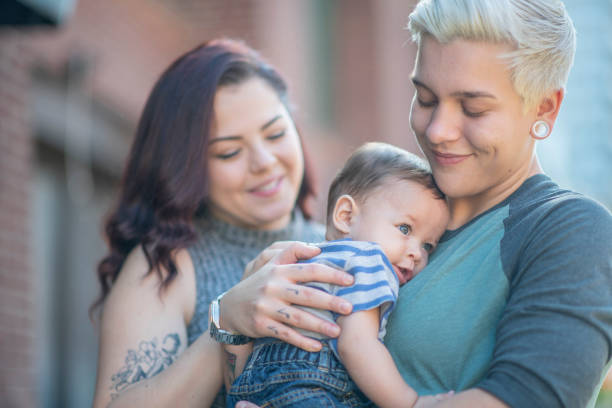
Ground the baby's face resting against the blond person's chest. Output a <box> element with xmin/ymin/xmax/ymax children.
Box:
<box><xmin>349</xmin><ymin>178</ymin><xmax>449</xmax><ymax>285</ymax></box>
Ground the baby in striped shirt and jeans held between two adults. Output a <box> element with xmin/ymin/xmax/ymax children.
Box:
<box><xmin>226</xmin><ymin>143</ymin><xmax>449</xmax><ymax>408</ymax></box>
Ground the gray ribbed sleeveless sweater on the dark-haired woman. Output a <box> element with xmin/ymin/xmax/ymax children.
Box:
<box><xmin>187</xmin><ymin>210</ymin><xmax>325</xmax><ymax>344</ymax></box>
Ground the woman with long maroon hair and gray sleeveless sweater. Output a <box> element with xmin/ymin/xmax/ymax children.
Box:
<box><xmin>94</xmin><ymin>39</ymin><xmax>351</xmax><ymax>407</ymax></box>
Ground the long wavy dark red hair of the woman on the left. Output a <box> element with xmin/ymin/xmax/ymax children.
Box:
<box><xmin>92</xmin><ymin>39</ymin><xmax>315</xmax><ymax>310</ymax></box>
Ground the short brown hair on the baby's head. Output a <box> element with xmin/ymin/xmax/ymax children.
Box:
<box><xmin>327</xmin><ymin>142</ymin><xmax>444</xmax><ymax>225</ymax></box>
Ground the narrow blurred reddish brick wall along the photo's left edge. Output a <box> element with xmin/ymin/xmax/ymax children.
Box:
<box><xmin>0</xmin><ymin>30</ymin><xmax>35</xmax><ymax>407</ymax></box>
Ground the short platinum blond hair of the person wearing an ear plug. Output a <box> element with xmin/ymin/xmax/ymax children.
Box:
<box><xmin>408</xmin><ymin>0</ymin><xmax>576</xmax><ymax>108</ymax></box>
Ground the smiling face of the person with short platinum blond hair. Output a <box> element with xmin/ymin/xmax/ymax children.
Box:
<box><xmin>410</xmin><ymin>35</ymin><xmax>537</xmax><ymax>226</ymax></box>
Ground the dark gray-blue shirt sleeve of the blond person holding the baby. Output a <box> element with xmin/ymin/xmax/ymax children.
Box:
<box><xmin>477</xmin><ymin>198</ymin><xmax>612</xmax><ymax>407</ymax></box>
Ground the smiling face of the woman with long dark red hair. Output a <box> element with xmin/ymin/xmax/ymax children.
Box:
<box><xmin>208</xmin><ymin>77</ymin><xmax>304</xmax><ymax>230</ymax></box>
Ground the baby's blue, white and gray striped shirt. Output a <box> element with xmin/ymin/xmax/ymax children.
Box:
<box><xmin>300</xmin><ymin>238</ymin><xmax>399</xmax><ymax>356</ymax></box>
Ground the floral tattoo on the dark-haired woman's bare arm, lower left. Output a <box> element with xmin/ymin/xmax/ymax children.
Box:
<box><xmin>111</xmin><ymin>333</ymin><xmax>181</xmax><ymax>399</ymax></box>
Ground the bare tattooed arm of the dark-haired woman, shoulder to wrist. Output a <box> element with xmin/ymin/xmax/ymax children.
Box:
<box><xmin>94</xmin><ymin>248</ymin><xmax>222</xmax><ymax>408</ymax></box>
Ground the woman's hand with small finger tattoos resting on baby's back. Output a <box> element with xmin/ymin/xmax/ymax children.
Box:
<box><xmin>220</xmin><ymin>242</ymin><xmax>353</xmax><ymax>351</ymax></box>
